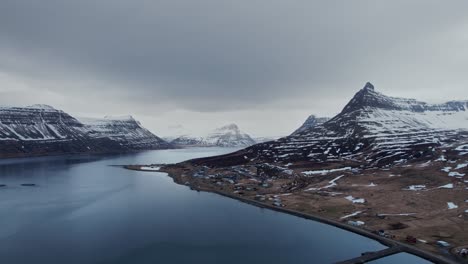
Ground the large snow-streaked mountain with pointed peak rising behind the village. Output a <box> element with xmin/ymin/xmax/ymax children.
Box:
<box><xmin>189</xmin><ymin>83</ymin><xmax>468</xmax><ymax>166</ymax></box>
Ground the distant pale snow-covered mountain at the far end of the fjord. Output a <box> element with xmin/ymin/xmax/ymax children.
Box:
<box><xmin>171</xmin><ymin>124</ymin><xmax>255</xmax><ymax>147</ymax></box>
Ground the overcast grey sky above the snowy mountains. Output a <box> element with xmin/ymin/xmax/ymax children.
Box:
<box><xmin>0</xmin><ymin>0</ymin><xmax>468</xmax><ymax>136</ymax></box>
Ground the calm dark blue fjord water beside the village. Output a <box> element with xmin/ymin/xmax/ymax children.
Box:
<box><xmin>0</xmin><ymin>148</ymin><xmax>424</xmax><ymax>264</ymax></box>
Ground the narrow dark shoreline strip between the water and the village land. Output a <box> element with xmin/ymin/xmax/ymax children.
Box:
<box><xmin>123</xmin><ymin>165</ymin><xmax>460</xmax><ymax>264</ymax></box>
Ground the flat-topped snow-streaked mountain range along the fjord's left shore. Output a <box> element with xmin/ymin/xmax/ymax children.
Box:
<box><xmin>0</xmin><ymin>105</ymin><xmax>170</xmax><ymax>157</ymax></box>
